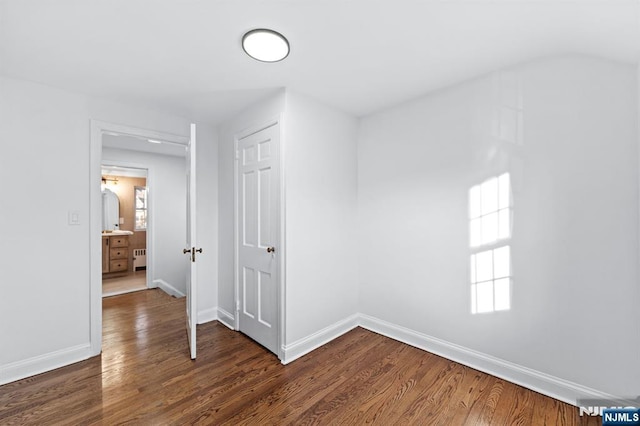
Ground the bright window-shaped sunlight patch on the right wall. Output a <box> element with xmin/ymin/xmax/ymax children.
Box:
<box><xmin>469</xmin><ymin>173</ymin><xmax>512</xmax><ymax>314</ymax></box>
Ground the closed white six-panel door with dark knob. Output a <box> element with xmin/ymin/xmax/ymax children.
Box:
<box><xmin>236</xmin><ymin>124</ymin><xmax>280</xmax><ymax>354</ymax></box>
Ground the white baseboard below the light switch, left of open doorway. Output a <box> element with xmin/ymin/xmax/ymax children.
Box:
<box><xmin>0</xmin><ymin>344</ymin><xmax>93</xmax><ymax>385</ymax></box>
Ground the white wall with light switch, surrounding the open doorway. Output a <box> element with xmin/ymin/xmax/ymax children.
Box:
<box><xmin>0</xmin><ymin>77</ymin><xmax>217</xmax><ymax>383</ymax></box>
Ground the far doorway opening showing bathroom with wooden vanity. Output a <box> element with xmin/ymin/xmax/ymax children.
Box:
<box><xmin>101</xmin><ymin>163</ymin><xmax>153</xmax><ymax>297</ymax></box>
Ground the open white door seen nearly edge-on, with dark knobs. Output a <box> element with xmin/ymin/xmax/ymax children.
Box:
<box><xmin>183</xmin><ymin>123</ymin><xmax>202</xmax><ymax>359</ymax></box>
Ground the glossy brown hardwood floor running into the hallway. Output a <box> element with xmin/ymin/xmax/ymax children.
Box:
<box><xmin>0</xmin><ymin>290</ymin><xmax>601</xmax><ymax>425</ymax></box>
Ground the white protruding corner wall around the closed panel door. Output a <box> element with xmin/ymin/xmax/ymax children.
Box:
<box><xmin>219</xmin><ymin>91</ymin><xmax>358</xmax><ymax>362</ymax></box>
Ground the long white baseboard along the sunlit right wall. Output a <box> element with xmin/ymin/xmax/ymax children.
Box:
<box><xmin>359</xmin><ymin>314</ymin><xmax>615</xmax><ymax>405</ymax></box>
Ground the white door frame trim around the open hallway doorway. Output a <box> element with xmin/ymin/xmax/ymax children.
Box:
<box><xmin>89</xmin><ymin>119</ymin><xmax>189</xmax><ymax>356</ymax></box>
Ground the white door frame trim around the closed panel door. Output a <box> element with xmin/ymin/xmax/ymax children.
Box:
<box><xmin>233</xmin><ymin>113</ymin><xmax>286</xmax><ymax>361</ymax></box>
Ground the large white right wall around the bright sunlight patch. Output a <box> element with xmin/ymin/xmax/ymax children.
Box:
<box><xmin>358</xmin><ymin>57</ymin><xmax>640</xmax><ymax>396</ymax></box>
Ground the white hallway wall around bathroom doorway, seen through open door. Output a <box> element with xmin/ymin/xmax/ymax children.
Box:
<box><xmin>102</xmin><ymin>148</ymin><xmax>187</xmax><ymax>294</ymax></box>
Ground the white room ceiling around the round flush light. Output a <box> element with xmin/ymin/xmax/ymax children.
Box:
<box><xmin>0</xmin><ymin>0</ymin><xmax>640</xmax><ymax>124</ymax></box>
